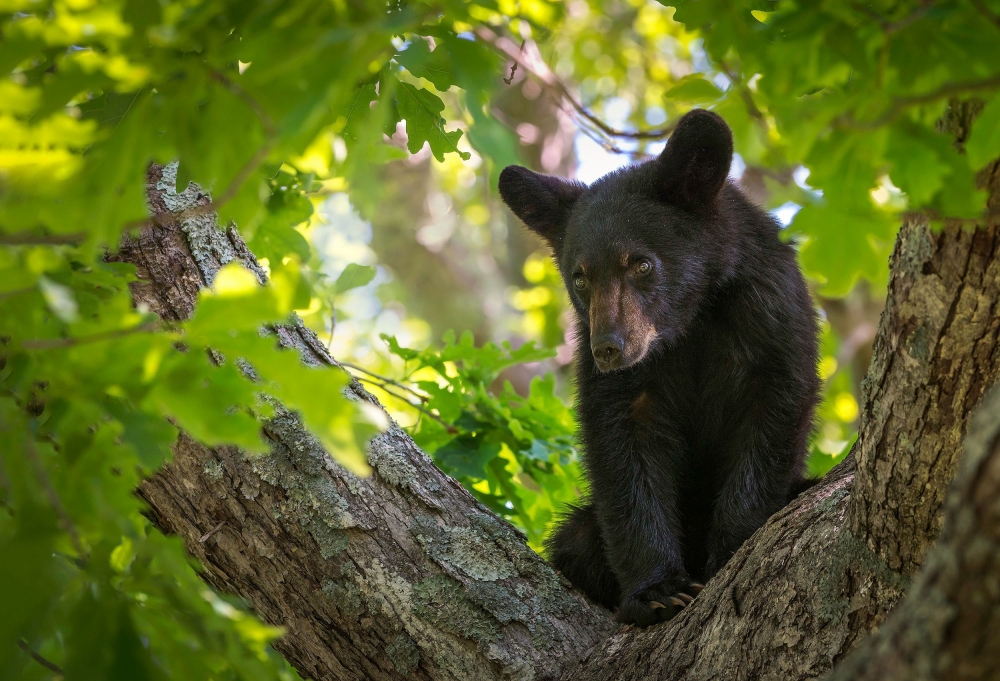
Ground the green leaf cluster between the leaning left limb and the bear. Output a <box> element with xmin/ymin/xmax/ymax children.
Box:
<box><xmin>376</xmin><ymin>332</ymin><xmax>585</xmax><ymax>548</ymax></box>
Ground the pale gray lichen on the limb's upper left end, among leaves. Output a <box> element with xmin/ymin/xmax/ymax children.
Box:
<box><xmin>156</xmin><ymin>161</ymin><xmax>267</xmax><ymax>286</ymax></box>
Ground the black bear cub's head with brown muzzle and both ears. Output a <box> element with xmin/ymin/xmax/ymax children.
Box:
<box><xmin>500</xmin><ymin>109</ymin><xmax>733</xmax><ymax>372</ymax></box>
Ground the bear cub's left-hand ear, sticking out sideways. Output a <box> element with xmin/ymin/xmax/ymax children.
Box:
<box><xmin>500</xmin><ymin>166</ymin><xmax>586</xmax><ymax>248</ymax></box>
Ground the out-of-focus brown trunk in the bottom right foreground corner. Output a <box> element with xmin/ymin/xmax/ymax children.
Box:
<box><xmin>831</xmin><ymin>390</ymin><xmax>1000</xmax><ymax>681</ymax></box>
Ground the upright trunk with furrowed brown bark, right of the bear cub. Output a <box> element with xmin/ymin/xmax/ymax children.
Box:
<box><xmin>847</xmin><ymin>211</ymin><xmax>1000</xmax><ymax>636</ymax></box>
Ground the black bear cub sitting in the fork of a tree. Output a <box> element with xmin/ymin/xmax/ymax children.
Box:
<box><xmin>500</xmin><ymin>110</ymin><xmax>819</xmax><ymax>626</ymax></box>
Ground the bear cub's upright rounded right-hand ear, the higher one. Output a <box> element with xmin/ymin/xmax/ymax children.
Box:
<box><xmin>656</xmin><ymin>109</ymin><xmax>733</xmax><ymax>211</ymax></box>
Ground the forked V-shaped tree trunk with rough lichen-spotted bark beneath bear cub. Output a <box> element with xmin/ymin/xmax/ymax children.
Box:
<box><xmin>117</xmin><ymin>157</ymin><xmax>1000</xmax><ymax>681</ymax></box>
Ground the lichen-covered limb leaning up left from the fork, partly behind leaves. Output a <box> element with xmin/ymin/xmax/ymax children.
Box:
<box><xmin>124</xmin><ymin>167</ymin><xmax>610</xmax><ymax>681</ymax></box>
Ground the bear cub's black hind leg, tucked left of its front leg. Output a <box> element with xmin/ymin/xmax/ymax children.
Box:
<box><xmin>545</xmin><ymin>504</ymin><xmax>621</xmax><ymax>610</ymax></box>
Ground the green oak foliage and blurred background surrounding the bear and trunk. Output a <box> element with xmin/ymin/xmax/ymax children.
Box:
<box><xmin>0</xmin><ymin>0</ymin><xmax>1000</xmax><ymax>679</ymax></box>
